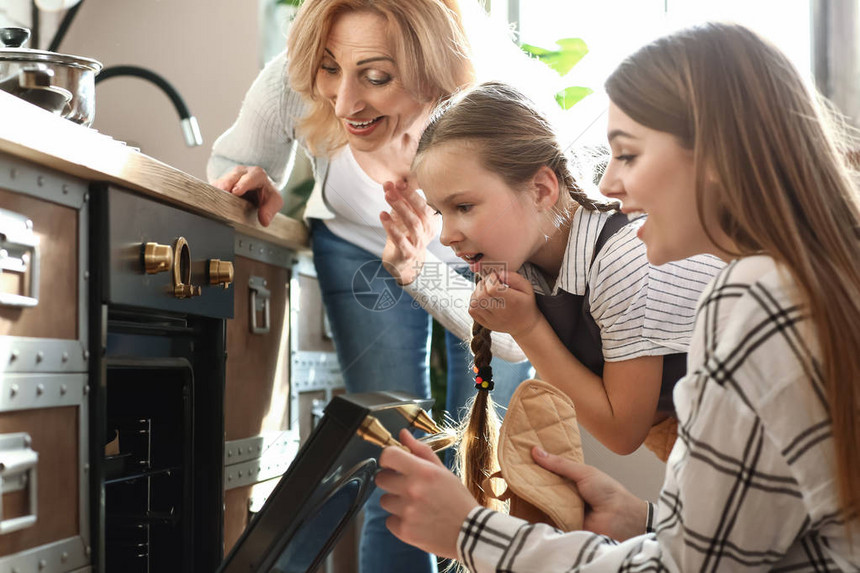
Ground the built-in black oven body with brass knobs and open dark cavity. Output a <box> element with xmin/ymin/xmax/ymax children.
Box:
<box><xmin>90</xmin><ymin>186</ymin><xmax>234</xmax><ymax>573</ymax></box>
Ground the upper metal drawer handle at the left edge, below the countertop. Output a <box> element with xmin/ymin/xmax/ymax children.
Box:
<box><xmin>0</xmin><ymin>209</ymin><xmax>39</xmax><ymax>307</ymax></box>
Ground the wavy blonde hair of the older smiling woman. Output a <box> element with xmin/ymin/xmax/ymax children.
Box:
<box><xmin>287</xmin><ymin>0</ymin><xmax>474</xmax><ymax>153</ymax></box>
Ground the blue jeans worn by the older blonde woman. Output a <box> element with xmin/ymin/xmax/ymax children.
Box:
<box><xmin>311</xmin><ymin>220</ymin><xmax>530</xmax><ymax>573</ymax></box>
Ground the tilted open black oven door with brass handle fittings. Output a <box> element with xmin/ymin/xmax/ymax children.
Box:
<box><xmin>219</xmin><ymin>392</ymin><xmax>432</xmax><ymax>573</ymax></box>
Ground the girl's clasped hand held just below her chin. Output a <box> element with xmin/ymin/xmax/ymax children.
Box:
<box><xmin>469</xmin><ymin>271</ymin><xmax>543</xmax><ymax>339</ymax></box>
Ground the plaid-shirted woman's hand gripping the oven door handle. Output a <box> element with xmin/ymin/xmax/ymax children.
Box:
<box><xmin>376</xmin><ymin>430</ymin><xmax>478</xmax><ymax>559</ymax></box>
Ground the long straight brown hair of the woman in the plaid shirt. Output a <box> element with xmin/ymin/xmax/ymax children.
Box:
<box><xmin>606</xmin><ymin>24</ymin><xmax>860</xmax><ymax>511</ymax></box>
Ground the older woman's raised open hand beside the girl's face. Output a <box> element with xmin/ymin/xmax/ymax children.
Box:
<box><xmin>379</xmin><ymin>181</ymin><xmax>438</xmax><ymax>285</ymax></box>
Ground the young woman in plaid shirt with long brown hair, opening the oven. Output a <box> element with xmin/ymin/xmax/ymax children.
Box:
<box><xmin>377</xmin><ymin>24</ymin><xmax>860</xmax><ymax>573</ymax></box>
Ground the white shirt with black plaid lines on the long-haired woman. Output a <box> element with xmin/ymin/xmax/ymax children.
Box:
<box><xmin>457</xmin><ymin>256</ymin><xmax>860</xmax><ymax>573</ymax></box>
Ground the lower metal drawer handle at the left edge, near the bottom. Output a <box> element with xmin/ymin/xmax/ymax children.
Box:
<box><xmin>0</xmin><ymin>432</ymin><xmax>39</xmax><ymax>535</ymax></box>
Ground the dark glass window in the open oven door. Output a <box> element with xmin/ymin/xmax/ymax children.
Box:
<box><xmin>269</xmin><ymin>461</ymin><xmax>376</xmax><ymax>573</ymax></box>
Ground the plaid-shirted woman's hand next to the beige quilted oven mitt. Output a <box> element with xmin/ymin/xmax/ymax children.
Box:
<box><xmin>532</xmin><ymin>446</ymin><xmax>648</xmax><ymax>541</ymax></box>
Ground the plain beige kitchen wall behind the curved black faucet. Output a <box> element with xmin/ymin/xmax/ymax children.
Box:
<box><xmin>61</xmin><ymin>0</ymin><xmax>272</xmax><ymax>179</ymax></box>
